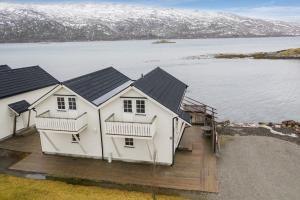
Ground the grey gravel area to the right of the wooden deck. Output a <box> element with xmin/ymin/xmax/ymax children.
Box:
<box><xmin>208</xmin><ymin>135</ymin><xmax>300</xmax><ymax>200</ymax></box>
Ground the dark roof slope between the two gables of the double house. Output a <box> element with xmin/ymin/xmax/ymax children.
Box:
<box><xmin>63</xmin><ymin>67</ymin><xmax>130</xmax><ymax>106</ymax></box>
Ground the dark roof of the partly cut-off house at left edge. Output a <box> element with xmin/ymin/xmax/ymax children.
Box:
<box><xmin>0</xmin><ymin>66</ymin><xmax>59</xmax><ymax>99</ymax></box>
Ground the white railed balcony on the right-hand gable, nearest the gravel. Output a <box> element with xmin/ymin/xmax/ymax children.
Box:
<box><xmin>105</xmin><ymin>114</ymin><xmax>157</xmax><ymax>139</ymax></box>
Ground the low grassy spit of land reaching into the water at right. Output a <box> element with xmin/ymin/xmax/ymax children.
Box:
<box><xmin>214</xmin><ymin>48</ymin><xmax>300</xmax><ymax>59</ymax></box>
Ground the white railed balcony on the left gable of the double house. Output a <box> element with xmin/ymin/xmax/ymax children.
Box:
<box><xmin>36</xmin><ymin>110</ymin><xmax>87</xmax><ymax>134</ymax></box>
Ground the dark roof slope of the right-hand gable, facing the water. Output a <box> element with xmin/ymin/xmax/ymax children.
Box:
<box><xmin>133</xmin><ymin>67</ymin><xmax>187</xmax><ymax>119</ymax></box>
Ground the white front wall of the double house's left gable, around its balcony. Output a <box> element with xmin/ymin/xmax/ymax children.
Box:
<box><xmin>35</xmin><ymin>88</ymin><xmax>102</xmax><ymax>158</ymax></box>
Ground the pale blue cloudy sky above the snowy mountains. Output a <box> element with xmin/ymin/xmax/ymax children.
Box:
<box><xmin>5</xmin><ymin>0</ymin><xmax>300</xmax><ymax>23</ymax></box>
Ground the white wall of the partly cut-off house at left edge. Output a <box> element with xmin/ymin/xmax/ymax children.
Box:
<box><xmin>0</xmin><ymin>86</ymin><xmax>55</xmax><ymax>140</ymax></box>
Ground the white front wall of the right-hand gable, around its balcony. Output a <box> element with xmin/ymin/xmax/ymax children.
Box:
<box><xmin>101</xmin><ymin>88</ymin><xmax>173</xmax><ymax>165</ymax></box>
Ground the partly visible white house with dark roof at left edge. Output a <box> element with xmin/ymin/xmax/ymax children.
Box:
<box><xmin>0</xmin><ymin>65</ymin><xmax>59</xmax><ymax>140</ymax></box>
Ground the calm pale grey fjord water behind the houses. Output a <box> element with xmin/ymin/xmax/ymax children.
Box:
<box><xmin>0</xmin><ymin>37</ymin><xmax>300</xmax><ymax>122</ymax></box>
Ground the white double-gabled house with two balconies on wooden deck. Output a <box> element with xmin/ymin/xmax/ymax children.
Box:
<box><xmin>31</xmin><ymin>67</ymin><xmax>190</xmax><ymax>165</ymax></box>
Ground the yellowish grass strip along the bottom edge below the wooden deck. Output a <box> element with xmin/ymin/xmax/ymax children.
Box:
<box><xmin>0</xmin><ymin>174</ymin><xmax>181</xmax><ymax>200</ymax></box>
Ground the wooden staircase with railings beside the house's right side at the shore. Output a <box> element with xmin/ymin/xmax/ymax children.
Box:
<box><xmin>181</xmin><ymin>96</ymin><xmax>218</xmax><ymax>153</ymax></box>
